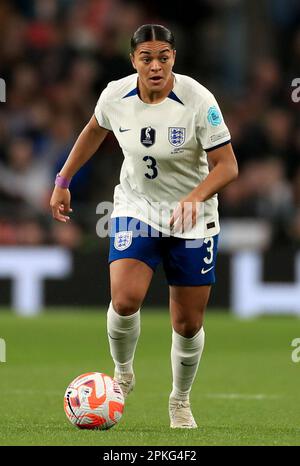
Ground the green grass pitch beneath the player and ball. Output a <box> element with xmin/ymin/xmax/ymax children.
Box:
<box><xmin>0</xmin><ymin>309</ymin><xmax>300</xmax><ymax>446</ymax></box>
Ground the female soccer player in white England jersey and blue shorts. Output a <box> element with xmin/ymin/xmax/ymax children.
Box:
<box><xmin>50</xmin><ymin>24</ymin><xmax>238</xmax><ymax>428</ymax></box>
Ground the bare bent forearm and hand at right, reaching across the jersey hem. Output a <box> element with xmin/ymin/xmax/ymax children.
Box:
<box><xmin>170</xmin><ymin>142</ymin><xmax>238</xmax><ymax>228</ymax></box>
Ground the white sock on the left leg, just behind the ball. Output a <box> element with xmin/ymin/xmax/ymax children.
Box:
<box><xmin>107</xmin><ymin>303</ymin><xmax>140</xmax><ymax>374</ymax></box>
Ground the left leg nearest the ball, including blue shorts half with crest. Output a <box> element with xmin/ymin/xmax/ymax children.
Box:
<box><xmin>107</xmin><ymin>217</ymin><xmax>160</xmax><ymax>396</ymax></box>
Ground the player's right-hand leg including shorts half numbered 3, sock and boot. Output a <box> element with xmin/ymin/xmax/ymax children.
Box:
<box><xmin>164</xmin><ymin>236</ymin><xmax>218</xmax><ymax>428</ymax></box>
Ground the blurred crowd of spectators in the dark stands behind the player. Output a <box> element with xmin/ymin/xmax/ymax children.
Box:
<box><xmin>0</xmin><ymin>0</ymin><xmax>300</xmax><ymax>248</ymax></box>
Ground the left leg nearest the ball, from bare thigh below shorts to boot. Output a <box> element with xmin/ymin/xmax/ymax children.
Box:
<box><xmin>107</xmin><ymin>259</ymin><xmax>153</xmax><ymax>396</ymax></box>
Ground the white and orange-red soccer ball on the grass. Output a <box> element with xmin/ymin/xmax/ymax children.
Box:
<box><xmin>64</xmin><ymin>372</ymin><xmax>124</xmax><ymax>430</ymax></box>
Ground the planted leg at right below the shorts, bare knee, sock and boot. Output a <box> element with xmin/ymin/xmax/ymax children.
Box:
<box><xmin>170</xmin><ymin>286</ymin><xmax>211</xmax><ymax>428</ymax></box>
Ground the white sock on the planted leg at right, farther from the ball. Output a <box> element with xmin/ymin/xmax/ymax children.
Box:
<box><xmin>170</xmin><ymin>327</ymin><xmax>205</xmax><ymax>401</ymax></box>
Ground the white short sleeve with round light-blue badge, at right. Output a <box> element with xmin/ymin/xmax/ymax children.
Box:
<box><xmin>196</xmin><ymin>94</ymin><xmax>230</xmax><ymax>152</ymax></box>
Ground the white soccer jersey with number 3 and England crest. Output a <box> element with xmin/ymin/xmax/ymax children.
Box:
<box><xmin>95</xmin><ymin>73</ymin><xmax>230</xmax><ymax>239</ymax></box>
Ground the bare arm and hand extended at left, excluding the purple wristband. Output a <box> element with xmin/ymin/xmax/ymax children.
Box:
<box><xmin>50</xmin><ymin>115</ymin><xmax>109</xmax><ymax>222</ymax></box>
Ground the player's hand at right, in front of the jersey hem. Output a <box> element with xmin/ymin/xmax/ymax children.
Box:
<box><xmin>170</xmin><ymin>194</ymin><xmax>201</xmax><ymax>233</ymax></box>
